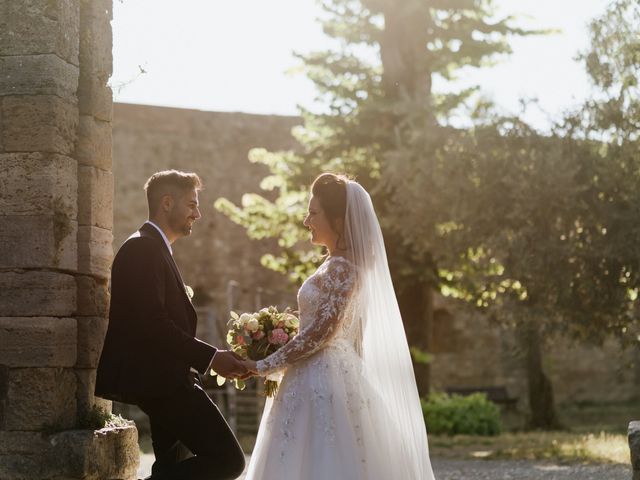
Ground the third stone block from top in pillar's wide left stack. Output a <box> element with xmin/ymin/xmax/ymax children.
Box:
<box><xmin>0</xmin><ymin>95</ymin><xmax>78</xmax><ymax>155</ymax></box>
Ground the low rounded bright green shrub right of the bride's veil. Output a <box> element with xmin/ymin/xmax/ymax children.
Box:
<box><xmin>422</xmin><ymin>393</ymin><xmax>502</xmax><ymax>435</ymax></box>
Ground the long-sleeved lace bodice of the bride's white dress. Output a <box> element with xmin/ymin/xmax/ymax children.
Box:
<box><xmin>257</xmin><ymin>257</ymin><xmax>355</xmax><ymax>375</ymax></box>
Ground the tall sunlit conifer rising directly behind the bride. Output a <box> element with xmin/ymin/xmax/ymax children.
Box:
<box><xmin>216</xmin><ymin>0</ymin><xmax>532</xmax><ymax>394</ymax></box>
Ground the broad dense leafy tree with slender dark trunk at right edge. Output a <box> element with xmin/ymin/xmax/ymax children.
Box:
<box><xmin>390</xmin><ymin>1</ymin><xmax>640</xmax><ymax>428</ymax></box>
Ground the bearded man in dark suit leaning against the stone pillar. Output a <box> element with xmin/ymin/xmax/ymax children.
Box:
<box><xmin>96</xmin><ymin>170</ymin><xmax>247</xmax><ymax>480</ymax></box>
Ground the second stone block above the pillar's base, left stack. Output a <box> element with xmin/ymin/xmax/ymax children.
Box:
<box><xmin>0</xmin><ymin>317</ymin><xmax>77</xmax><ymax>367</ymax></box>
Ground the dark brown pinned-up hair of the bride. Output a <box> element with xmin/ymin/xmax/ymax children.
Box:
<box><xmin>311</xmin><ymin>173</ymin><xmax>349</xmax><ymax>248</ymax></box>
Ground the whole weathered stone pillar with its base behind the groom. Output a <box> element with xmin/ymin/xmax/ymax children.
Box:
<box><xmin>0</xmin><ymin>0</ymin><xmax>138</xmax><ymax>480</ymax></box>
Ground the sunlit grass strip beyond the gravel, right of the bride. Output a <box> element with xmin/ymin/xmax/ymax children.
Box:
<box><xmin>429</xmin><ymin>403</ymin><xmax>640</xmax><ymax>464</ymax></box>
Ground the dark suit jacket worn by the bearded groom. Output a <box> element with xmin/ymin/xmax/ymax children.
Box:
<box><xmin>96</xmin><ymin>223</ymin><xmax>216</xmax><ymax>403</ymax></box>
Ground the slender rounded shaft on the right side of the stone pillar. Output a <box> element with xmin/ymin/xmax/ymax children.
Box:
<box><xmin>74</xmin><ymin>0</ymin><xmax>113</xmax><ymax>424</ymax></box>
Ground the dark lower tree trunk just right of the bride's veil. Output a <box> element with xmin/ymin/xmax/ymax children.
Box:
<box><xmin>398</xmin><ymin>282</ymin><xmax>433</xmax><ymax>397</ymax></box>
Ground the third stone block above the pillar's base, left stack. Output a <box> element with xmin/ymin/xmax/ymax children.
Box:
<box><xmin>0</xmin><ymin>271</ymin><xmax>77</xmax><ymax>316</ymax></box>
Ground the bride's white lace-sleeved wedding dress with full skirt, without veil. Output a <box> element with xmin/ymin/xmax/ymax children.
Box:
<box><xmin>247</xmin><ymin>257</ymin><xmax>393</xmax><ymax>480</ymax></box>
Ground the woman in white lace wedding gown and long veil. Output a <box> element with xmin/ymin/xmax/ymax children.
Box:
<box><xmin>241</xmin><ymin>173</ymin><xmax>434</xmax><ymax>480</ymax></box>
